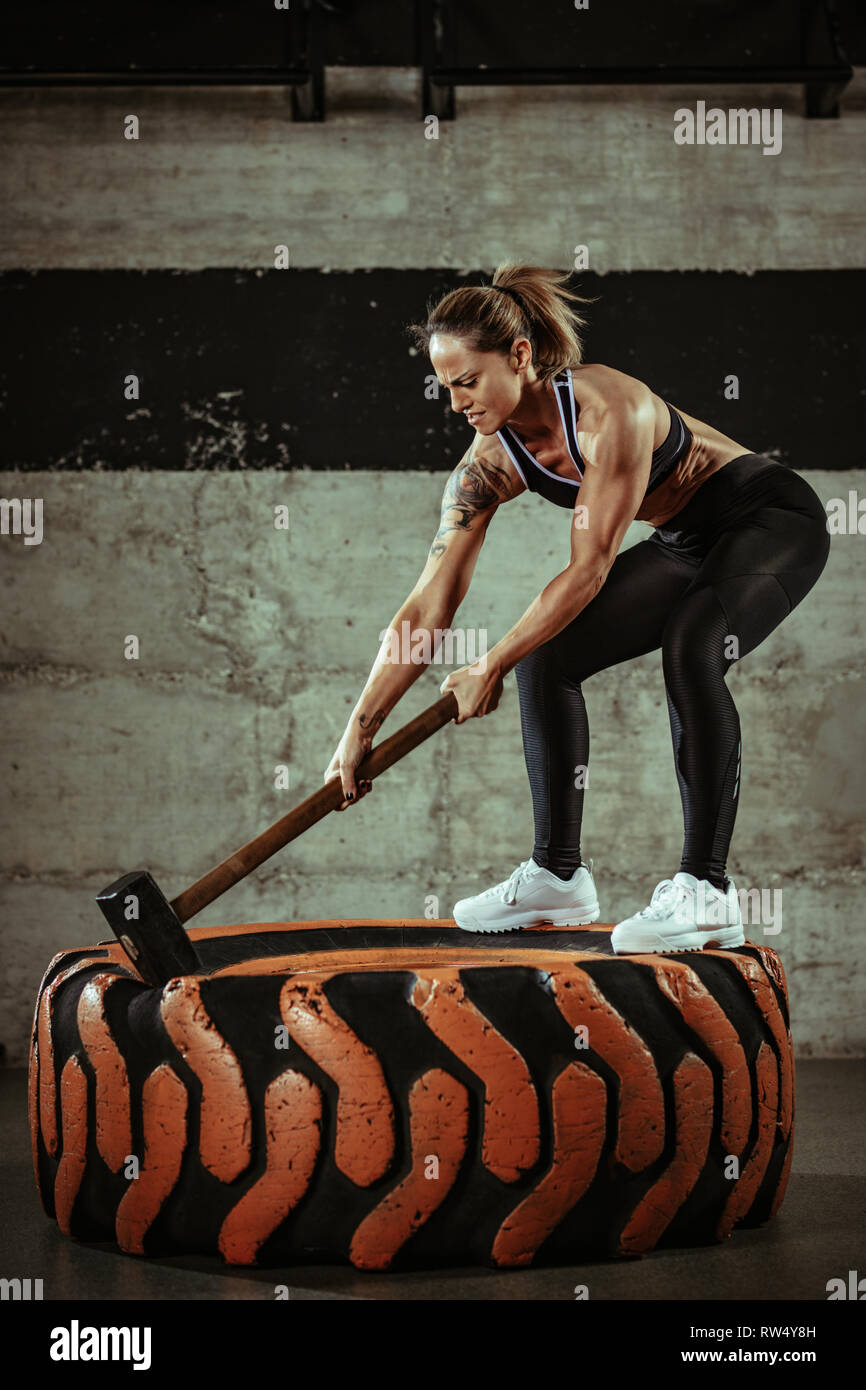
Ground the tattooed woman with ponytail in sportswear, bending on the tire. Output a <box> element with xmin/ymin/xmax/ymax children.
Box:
<box><xmin>325</xmin><ymin>263</ymin><xmax>830</xmax><ymax>952</ymax></box>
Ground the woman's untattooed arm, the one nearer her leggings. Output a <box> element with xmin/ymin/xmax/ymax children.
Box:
<box><xmin>487</xmin><ymin>388</ymin><xmax>655</xmax><ymax>677</ymax></box>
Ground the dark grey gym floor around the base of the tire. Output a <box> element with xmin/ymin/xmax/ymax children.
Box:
<box><xmin>0</xmin><ymin>1061</ymin><xmax>866</xmax><ymax>1301</ymax></box>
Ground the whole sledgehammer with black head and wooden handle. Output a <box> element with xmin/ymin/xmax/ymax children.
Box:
<box><xmin>96</xmin><ymin>691</ymin><xmax>459</xmax><ymax>986</ymax></box>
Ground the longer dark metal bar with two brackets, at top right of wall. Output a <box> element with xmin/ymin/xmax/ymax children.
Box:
<box><xmin>416</xmin><ymin>0</ymin><xmax>853</xmax><ymax>121</ymax></box>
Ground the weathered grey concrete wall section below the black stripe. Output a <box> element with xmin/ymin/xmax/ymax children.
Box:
<box><xmin>0</xmin><ymin>471</ymin><xmax>866</xmax><ymax>1061</ymax></box>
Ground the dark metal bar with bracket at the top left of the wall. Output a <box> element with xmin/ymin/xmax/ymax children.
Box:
<box><xmin>0</xmin><ymin>0</ymin><xmax>327</xmax><ymax>121</ymax></box>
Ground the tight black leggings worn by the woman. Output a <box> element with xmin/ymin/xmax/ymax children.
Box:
<box><xmin>514</xmin><ymin>453</ymin><xmax>830</xmax><ymax>888</ymax></box>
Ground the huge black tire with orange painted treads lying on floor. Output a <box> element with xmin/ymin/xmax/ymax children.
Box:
<box><xmin>28</xmin><ymin>919</ymin><xmax>794</xmax><ymax>1270</ymax></box>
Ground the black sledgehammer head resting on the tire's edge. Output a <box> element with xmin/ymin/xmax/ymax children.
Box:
<box><xmin>96</xmin><ymin>869</ymin><xmax>202</xmax><ymax>986</ymax></box>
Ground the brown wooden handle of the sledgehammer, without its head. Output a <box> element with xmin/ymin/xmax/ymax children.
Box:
<box><xmin>171</xmin><ymin>691</ymin><xmax>459</xmax><ymax>922</ymax></box>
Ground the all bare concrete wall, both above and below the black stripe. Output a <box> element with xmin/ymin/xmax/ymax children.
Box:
<box><xmin>0</xmin><ymin>72</ymin><xmax>866</xmax><ymax>1062</ymax></box>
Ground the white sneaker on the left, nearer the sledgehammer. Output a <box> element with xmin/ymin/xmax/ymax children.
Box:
<box><xmin>453</xmin><ymin>859</ymin><xmax>599</xmax><ymax>931</ymax></box>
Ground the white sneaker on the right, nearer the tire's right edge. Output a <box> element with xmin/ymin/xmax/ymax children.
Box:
<box><xmin>610</xmin><ymin>873</ymin><xmax>745</xmax><ymax>954</ymax></box>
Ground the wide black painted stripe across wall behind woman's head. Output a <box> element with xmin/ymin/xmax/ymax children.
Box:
<box><xmin>0</xmin><ymin>270</ymin><xmax>866</xmax><ymax>471</ymax></box>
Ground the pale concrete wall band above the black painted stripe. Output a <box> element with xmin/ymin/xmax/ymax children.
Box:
<box><xmin>0</xmin><ymin>68</ymin><xmax>866</xmax><ymax>274</ymax></box>
